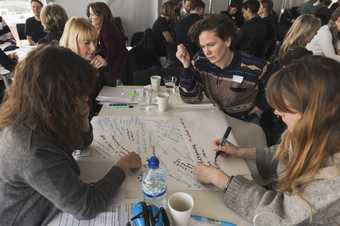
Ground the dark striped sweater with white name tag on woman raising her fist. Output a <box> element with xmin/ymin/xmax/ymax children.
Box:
<box><xmin>180</xmin><ymin>51</ymin><xmax>266</xmax><ymax>119</ymax></box>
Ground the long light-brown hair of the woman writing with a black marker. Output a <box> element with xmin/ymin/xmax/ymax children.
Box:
<box><xmin>266</xmin><ymin>56</ymin><xmax>340</xmax><ymax>194</ymax></box>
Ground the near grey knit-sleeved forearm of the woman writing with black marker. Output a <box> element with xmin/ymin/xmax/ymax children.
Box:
<box><xmin>224</xmin><ymin>176</ymin><xmax>314</xmax><ymax>226</ymax></box>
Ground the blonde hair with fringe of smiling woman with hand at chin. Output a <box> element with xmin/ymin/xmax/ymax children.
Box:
<box><xmin>59</xmin><ymin>17</ymin><xmax>98</xmax><ymax>54</ymax></box>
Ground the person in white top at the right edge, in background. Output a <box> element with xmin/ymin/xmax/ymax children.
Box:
<box><xmin>306</xmin><ymin>8</ymin><xmax>340</xmax><ymax>62</ymax></box>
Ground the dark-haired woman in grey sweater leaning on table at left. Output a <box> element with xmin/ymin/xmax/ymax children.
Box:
<box><xmin>0</xmin><ymin>45</ymin><xmax>141</xmax><ymax>225</ymax></box>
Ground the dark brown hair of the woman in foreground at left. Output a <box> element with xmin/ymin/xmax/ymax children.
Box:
<box><xmin>0</xmin><ymin>45</ymin><xmax>96</xmax><ymax>146</ymax></box>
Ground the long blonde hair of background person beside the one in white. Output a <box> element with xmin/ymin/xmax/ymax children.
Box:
<box><xmin>279</xmin><ymin>14</ymin><xmax>321</xmax><ymax>58</ymax></box>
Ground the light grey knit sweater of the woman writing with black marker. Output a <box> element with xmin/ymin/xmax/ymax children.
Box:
<box><xmin>224</xmin><ymin>146</ymin><xmax>340</xmax><ymax>226</ymax></box>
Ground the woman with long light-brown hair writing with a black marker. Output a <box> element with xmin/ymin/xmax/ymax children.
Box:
<box><xmin>194</xmin><ymin>56</ymin><xmax>340</xmax><ymax>226</ymax></box>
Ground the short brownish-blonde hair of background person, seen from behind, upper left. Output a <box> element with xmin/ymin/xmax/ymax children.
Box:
<box><xmin>40</xmin><ymin>4</ymin><xmax>68</xmax><ymax>32</ymax></box>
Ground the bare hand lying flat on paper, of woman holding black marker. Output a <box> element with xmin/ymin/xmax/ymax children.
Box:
<box><xmin>194</xmin><ymin>164</ymin><xmax>230</xmax><ymax>190</ymax></box>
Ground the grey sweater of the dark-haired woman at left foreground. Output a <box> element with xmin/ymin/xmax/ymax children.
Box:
<box><xmin>0</xmin><ymin>127</ymin><xmax>125</xmax><ymax>226</ymax></box>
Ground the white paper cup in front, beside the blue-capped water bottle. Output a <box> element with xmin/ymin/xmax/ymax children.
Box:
<box><xmin>168</xmin><ymin>192</ymin><xmax>194</xmax><ymax>226</ymax></box>
